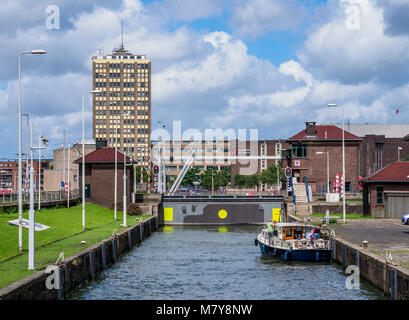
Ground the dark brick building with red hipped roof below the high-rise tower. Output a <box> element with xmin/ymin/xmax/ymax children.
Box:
<box><xmin>75</xmin><ymin>147</ymin><xmax>133</xmax><ymax>210</ymax></box>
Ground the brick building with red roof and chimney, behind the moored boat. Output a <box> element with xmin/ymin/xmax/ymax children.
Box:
<box><xmin>287</xmin><ymin>122</ymin><xmax>362</xmax><ymax>192</ymax></box>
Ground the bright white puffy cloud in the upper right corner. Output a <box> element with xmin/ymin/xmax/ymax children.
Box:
<box><xmin>298</xmin><ymin>0</ymin><xmax>409</xmax><ymax>83</ymax></box>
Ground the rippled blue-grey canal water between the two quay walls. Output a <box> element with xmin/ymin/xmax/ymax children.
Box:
<box><xmin>71</xmin><ymin>226</ymin><xmax>385</xmax><ymax>300</ymax></box>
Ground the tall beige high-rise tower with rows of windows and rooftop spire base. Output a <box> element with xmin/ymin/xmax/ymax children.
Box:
<box><xmin>92</xmin><ymin>45</ymin><xmax>151</xmax><ymax>165</ymax></box>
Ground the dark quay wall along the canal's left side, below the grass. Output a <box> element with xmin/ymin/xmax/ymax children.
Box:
<box><xmin>0</xmin><ymin>216</ymin><xmax>159</xmax><ymax>300</ymax></box>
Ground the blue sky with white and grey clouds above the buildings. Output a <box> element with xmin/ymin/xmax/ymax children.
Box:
<box><xmin>0</xmin><ymin>0</ymin><xmax>409</xmax><ymax>160</ymax></box>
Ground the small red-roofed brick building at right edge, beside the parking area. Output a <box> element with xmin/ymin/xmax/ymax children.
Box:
<box><xmin>363</xmin><ymin>162</ymin><xmax>409</xmax><ymax>219</ymax></box>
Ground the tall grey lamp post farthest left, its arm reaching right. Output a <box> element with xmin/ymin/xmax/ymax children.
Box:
<box><xmin>18</xmin><ymin>49</ymin><xmax>46</xmax><ymax>251</ymax></box>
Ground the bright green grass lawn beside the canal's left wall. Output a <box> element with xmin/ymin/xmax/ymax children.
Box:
<box><xmin>0</xmin><ymin>203</ymin><xmax>150</xmax><ymax>288</ymax></box>
